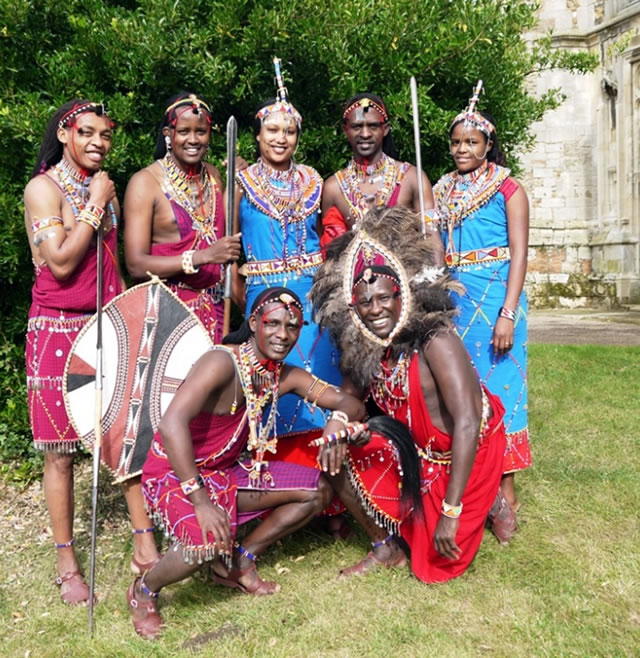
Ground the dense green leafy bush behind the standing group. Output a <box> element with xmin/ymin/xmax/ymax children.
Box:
<box><xmin>0</xmin><ymin>0</ymin><xmax>595</xmax><ymax>482</ymax></box>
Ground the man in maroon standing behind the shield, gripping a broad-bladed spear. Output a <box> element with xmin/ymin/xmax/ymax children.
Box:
<box><xmin>124</xmin><ymin>93</ymin><xmax>240</xmax><ymax>343</ymax></box>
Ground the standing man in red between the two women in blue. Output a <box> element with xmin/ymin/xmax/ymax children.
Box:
<box><xmin>321</xmin><ymin>93</ymin><xmax>433</xmax><ymax>249</ymax></box>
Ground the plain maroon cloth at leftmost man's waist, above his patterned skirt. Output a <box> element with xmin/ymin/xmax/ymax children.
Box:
<box><xmin>31</xmin><ymin>228</ymin><xmax>121</xmax><ymax>313</ymax></box>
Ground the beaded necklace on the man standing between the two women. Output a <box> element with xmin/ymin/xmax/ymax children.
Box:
<box><xmin>336</xmin><ymin>153</ymin><xmax>398</xmax><ymax>220</ymax></box>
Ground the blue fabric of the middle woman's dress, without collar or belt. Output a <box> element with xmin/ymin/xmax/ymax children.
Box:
<box><xmin>239</xmin><ymin>196</ymin><xmax>342</xmax><ymax>436</ymax></box>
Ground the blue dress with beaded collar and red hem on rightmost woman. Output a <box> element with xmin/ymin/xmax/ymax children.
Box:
<box><xmin>434</xmin><ymin>163</ymin><xmax>531</xmax><ymax>473</ymax></box>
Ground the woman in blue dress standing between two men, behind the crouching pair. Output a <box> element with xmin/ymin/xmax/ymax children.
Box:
<box><xmin>236</xmin><ymin>82</ymin><xmax>341</xmax><ymax>466</ymax></box>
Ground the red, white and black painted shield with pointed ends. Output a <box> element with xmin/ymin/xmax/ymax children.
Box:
<box><xmin>63</xmin><ymin>277</ymin><xmax>212</xmax><ymax>482</ymax></box>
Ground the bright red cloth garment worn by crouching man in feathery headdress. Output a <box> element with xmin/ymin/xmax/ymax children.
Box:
<box><xmin>349</xmin><ymin>353</ymin><xmax>506</xmax><ymax>583</ymax></box>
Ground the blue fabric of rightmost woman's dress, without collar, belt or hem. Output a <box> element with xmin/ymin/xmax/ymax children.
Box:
<box><xmin>442</xmin><ymin>192</ymin><xmax>528</xmax><ymax>444</ymax></box>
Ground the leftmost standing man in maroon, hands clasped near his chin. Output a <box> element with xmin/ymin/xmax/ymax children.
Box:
<box><xmin>24</xmin><ymin>99</ymin><xmax>158</xmax><ymax>604</ymax></box>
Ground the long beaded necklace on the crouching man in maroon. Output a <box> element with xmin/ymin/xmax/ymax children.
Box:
<box><xmin>238</xmin><ymin>340</ymin><xmax>282</xmax><ymax>486</ymax></box>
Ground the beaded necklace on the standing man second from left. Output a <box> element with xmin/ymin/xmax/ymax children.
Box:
<box><xmin>158</xmin><ymin>153</ymin><xmax>217</xmax><ymax>244</ymax></box>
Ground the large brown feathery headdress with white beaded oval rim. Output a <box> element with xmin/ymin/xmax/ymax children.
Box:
<box><xmin>310</xmin><ymin>206</ymin><xmax>461</xmax><ymax>390</ymax></box>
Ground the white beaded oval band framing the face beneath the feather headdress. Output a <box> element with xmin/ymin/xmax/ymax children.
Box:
<box><xmin>342</xmin><ymin>230</ymin><xmax>411</xmax><ymax>347</ymax></box>
